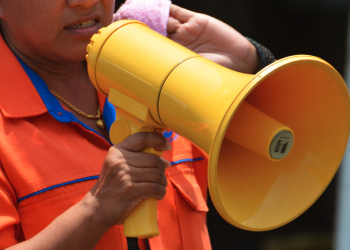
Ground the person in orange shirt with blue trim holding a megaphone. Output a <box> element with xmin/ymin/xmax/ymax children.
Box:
<box><xmin>0</xmin><ymin>0</ymin><xmax>270</xmax><ymax>250</ymax></box>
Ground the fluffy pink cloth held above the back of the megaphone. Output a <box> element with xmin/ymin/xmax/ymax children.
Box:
<box><xmin>114</xmin><ymin>0</ymin><xmax>171</xmax><ymax>36</ymax></box>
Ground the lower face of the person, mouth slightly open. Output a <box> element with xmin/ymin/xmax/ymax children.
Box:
<box><xmin>0</xmin><ymin>0</ymin><xmax>115</xmax><ymax>63</ymax></box>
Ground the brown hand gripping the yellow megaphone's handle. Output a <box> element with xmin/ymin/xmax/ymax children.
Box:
<box><xmin>85</xmin><ymin>133</ymin><xmax>171</xmax><ymax>226</ymax></box>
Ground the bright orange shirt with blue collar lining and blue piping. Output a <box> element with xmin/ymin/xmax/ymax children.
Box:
<box><xmin>0</xmin><ymin>34</ymin><xmax>211</xmax><ymax>250</ymax></box>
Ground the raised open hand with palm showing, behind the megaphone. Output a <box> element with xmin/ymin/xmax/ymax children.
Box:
<box><xmin>167</xmin><ymin>5</ymin><xmax>259</xmax><ymax>73</ymax></box>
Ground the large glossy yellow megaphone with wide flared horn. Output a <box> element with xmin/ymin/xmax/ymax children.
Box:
<box><xmin>87</xmin><ymin>20</ymin><xmax>350</xmax><ymax>238</ymax></box>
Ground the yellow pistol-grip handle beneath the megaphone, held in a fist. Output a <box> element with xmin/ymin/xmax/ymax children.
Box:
<box><xmin>109</xmin><ymin>109</ymin><xmax>162</xmax><ymax>238</ymax></box>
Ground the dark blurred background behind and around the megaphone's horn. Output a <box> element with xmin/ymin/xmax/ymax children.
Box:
<box><xmin>117</xmin><ymin>0</ymin><xmax>350</xmax><ymax>250</ymax></box>
